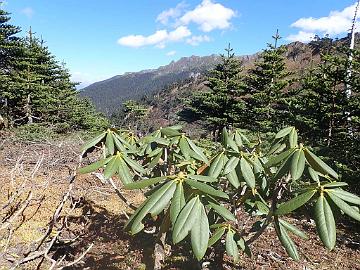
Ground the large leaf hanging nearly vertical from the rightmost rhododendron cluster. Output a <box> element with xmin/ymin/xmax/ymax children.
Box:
<box><xmin>315</xmin><ymin>194</ymin><xmax>336</xmax><ymax>250</ymax></box>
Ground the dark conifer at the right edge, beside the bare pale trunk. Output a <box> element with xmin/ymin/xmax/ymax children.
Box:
<box><xmin>291</xmin><ymin>40</ymin><xmax>360</xmax><ymax>191</ymax></box>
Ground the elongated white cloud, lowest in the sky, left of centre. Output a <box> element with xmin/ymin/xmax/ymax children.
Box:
<box><xmin>118</xmin><ymin>26</ymin><xmax>191</xmax><ymax>48</ymax></box>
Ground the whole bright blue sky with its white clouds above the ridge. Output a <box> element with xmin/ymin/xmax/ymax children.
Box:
<box><xmin>3</xmin><ymin>0</ymin><xmax>355</xmax><ymax>86</ymax></box>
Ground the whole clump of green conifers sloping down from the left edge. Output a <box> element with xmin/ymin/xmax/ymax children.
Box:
<box><xmin>0</xmin><ymin>6</ymin><xmax>109</xmax><ymax>131</ymax></box>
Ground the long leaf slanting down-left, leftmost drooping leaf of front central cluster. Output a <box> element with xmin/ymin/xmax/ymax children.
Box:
<box><xmin>131</xmin><ymin>181</ymin><xmax>175</xmax><ymax>233</ymax></box>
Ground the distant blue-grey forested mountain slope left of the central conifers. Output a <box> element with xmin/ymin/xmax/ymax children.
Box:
<box><xmin>81</xmin><ymin>54</ymin><xmax>256</xmax><ymax>115</ymax></box>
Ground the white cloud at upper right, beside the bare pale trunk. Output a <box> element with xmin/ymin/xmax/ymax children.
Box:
<box><xmin>287</xmin><ymin>3</ymin><xmax>356</xmax><ymax>40</ymax></box>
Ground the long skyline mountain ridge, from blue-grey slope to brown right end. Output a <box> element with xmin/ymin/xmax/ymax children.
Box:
<box><xmin>80</xmin><ymin>33</ymin><xmax>360</xmax><ymax>116</ymax></box>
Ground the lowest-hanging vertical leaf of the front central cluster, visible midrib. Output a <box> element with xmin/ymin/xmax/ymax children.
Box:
<box><xmin>191</xmin><ymin>204</ymin><xmax>210</xmax><ymax>261</ymax></box>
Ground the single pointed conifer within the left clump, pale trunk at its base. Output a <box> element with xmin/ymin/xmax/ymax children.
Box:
<box><xmin>9</xmin><ymin>29</ymin><xmax>56</xmax><ymax>124</ymax></box>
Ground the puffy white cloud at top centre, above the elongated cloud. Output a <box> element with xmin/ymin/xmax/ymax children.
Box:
<box><xmin>179</xmin><ymin>0</ymin><xmax>235</xmax><ymax>32</ymax></box>
